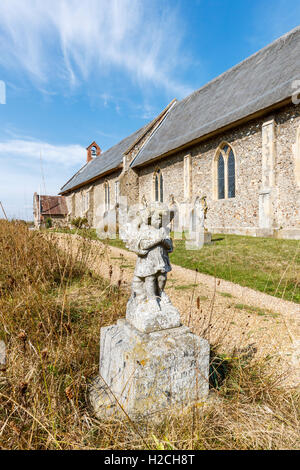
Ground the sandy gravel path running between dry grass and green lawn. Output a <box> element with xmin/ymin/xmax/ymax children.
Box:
<box><xmin>53</xmin><ymin>233</ymin><xmax>300</xmax><ymax>385</ymax></box>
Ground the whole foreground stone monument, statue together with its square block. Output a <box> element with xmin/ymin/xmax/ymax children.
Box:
<box><xmin>90</xmin><ymin>205</ymin><xmax>209</xmax><ymax>419</ymax></box>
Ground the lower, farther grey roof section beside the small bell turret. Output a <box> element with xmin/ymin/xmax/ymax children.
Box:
<box><xmin>60</xmin><ymin>125</ymin><xmax>147</xmax><ymax>193</ymax></box>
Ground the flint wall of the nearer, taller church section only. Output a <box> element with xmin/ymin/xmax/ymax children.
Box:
<box><xmin>139</xmin><ymin>101</ymin><xmax>300</xmax><ymax>238</ymax></box>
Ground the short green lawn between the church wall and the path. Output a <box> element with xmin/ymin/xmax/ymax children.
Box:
<box><xmin>55</xmin><ymin>230</ymin><xmax>300</xmax><ymax>303</ymax></box>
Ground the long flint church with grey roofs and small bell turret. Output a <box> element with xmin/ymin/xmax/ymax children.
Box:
<box><xmin>60</xmin><ymin>27</ymin><xmax>300</xmax><ymax>239</ymax></box>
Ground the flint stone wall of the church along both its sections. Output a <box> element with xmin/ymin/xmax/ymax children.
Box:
<box><xmin>67</xmin><ymin>105</ymin><xmax>300</xmax><ymax>239</ymax></box>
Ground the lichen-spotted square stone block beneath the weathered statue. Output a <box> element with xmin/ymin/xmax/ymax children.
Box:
<box><xmin>90</xmin><ymin>320</ymin><xmax>209</xmax><ymax>419</ymax></box>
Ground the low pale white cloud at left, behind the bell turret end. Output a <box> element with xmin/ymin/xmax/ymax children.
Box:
<box><xmin>0</xmin><ymin>139</ymin><xmax>86</xmax><ymax>220</ymax></box>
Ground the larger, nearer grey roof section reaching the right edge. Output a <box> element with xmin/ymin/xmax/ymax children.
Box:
<box><xmin>131</xmin><ymin>27</ymin><xmax>300</xmax><ymax>167</ymax></box>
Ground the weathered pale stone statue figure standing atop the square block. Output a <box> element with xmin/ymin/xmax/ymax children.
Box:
<box><xmin>126</xmin><ymin>205</ymin><xmax>180</xmax><ymax>333</ymax></box>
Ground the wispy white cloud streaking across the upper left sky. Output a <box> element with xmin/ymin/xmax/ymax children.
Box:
<box><xmin>0</xmin><ymin>0</ymin><xmax>191</xmax><ymax>98</ymax></box>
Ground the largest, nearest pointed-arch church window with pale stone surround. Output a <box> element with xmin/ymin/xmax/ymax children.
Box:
<box><xmin>216</xmin><ymin>144</ymin><xmax>236</xmax><ymax>199</ymax></box>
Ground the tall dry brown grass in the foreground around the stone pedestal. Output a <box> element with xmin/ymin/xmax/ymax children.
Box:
<box><xmin>0</xmin><ymin>221</ymin><xmax>300</xmax><ymax>449</ymax></box>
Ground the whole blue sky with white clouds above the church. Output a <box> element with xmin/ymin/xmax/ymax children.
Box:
<box><xmin>0</xmin><ymin>0</ymin><xmax>300</xmax><ymax>219</ymax></box>
